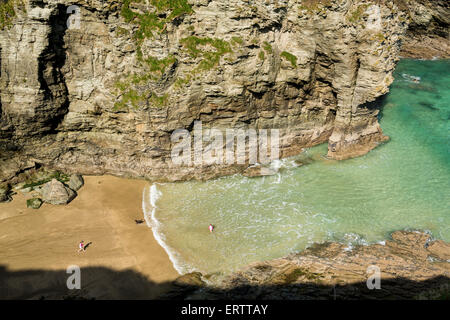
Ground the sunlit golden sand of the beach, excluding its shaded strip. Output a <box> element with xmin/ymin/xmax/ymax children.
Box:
<box><xmin>0</xmin><ymin>176</ymin><xmax>179</xmax><ymax>299</ymax></box>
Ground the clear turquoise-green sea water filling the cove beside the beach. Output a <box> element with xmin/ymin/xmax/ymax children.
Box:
<box><xmin>143</xmin><ymin>60</ymin><xmax>450</xmax><ymax>273</ymax></box>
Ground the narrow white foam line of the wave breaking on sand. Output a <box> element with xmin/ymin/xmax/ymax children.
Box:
<box><xmin>142</xmin><ymin>183</ymin><xmax>189</xmax><ymax>275</ymax></box>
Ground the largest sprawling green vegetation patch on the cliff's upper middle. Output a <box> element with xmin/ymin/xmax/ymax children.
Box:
<box><xmin>114</xmin><ymin>0</ymin><xmax>244</xmax><ymax>110</ymax></box>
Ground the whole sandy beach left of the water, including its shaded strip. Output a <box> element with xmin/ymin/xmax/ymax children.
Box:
<box><xmin>0</xmin><ymin>176</ymin><xmax>179</xmax><ymax>299</ymax></box>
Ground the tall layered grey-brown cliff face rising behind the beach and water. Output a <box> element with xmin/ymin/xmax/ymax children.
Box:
<box><xmin>0</xmin><ymin>0</ymin><xmax>448</xmax><ymax>185</ymax></box>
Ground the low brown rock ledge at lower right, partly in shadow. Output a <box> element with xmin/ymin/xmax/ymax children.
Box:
<box><xmin>183</xmin><ymin>231</ymin><xmax>450</xmax><ymax>299</ymax></box>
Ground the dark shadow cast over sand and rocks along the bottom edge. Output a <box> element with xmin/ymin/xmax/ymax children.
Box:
<box><xmin>0</xmin><ymin>266</ymin><xmax>450</xmax><ymax>300</ymax></box>
